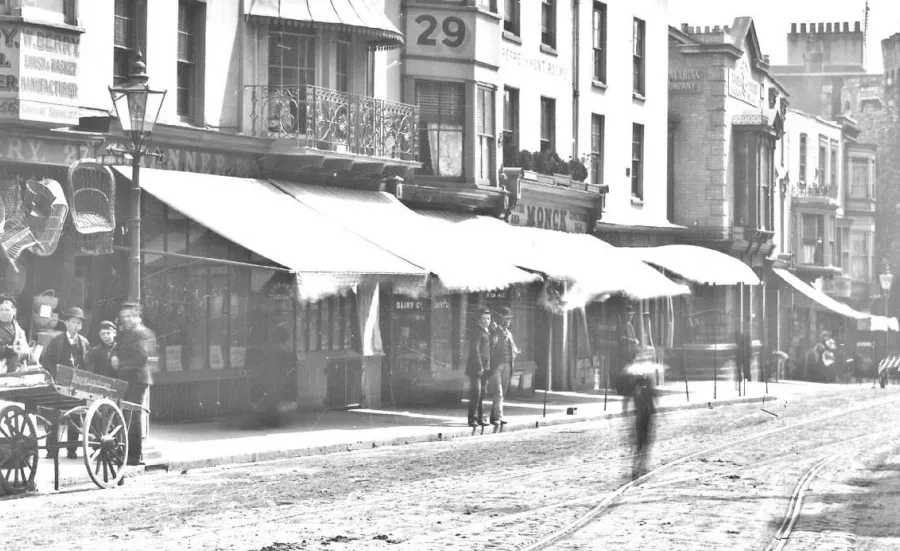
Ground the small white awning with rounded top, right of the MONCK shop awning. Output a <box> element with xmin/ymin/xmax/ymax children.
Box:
<box><xmin>624</xmin><ymin>245</ymin><xmax>759</xmax><ymax>285</ymax></box>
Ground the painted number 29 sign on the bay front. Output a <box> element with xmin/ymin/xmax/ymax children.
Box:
<box><xmin>406</xmin><ymin>10</ymin><xmax>475</xmax><ymax>57</ymax></box>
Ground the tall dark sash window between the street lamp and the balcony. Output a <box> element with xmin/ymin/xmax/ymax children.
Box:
<box><xmin>176</xmin><ymin>0</ymin><xmax>206</xmax><ymax>122</ymax></box>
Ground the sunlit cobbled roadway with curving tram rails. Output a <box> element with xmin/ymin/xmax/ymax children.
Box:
<box><xmin>0</xmin><ymin>386</ymin><xmax>900</xmax><ymax>551</ymax></box>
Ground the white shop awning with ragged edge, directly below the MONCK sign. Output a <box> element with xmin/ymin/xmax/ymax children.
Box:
<box><xmin>418</xmin><ymin>210</ymin><xmax>690</xmax><ymax>305</ymax></box>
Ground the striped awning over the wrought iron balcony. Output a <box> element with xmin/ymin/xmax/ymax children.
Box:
<box><xmin>244</xmin><ymin>0</ymin><xmax>404</xmax><ymax>49</ymax></box>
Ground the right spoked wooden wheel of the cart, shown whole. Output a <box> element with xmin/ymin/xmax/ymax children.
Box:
<box><xmin>81</xmin><ymin>398</ymin><xmax>128</xmax><ymax>488</ymax></box>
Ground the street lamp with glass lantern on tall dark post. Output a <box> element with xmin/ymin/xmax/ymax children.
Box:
<box><xmin>109</xmin><ymin>51</ymin><xmax>166</xmax><ymax>301</ymax></box>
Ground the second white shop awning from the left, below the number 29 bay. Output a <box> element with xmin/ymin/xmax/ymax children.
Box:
<box><xmin>275</xmin><ymin>180</ymin><xmax>540</xmax><ymax>292</ymax></box>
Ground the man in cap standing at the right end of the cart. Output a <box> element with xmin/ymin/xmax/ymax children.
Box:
<box><xmin>110</xmin><ymin>302</ymin><xmax>156</xmax><ymax>465</ymax></box>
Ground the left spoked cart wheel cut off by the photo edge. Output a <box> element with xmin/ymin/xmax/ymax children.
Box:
<box><xmin>0</xmin><ymin>406</ymin><xmax>38</xmax><ymax>494</ymax></box>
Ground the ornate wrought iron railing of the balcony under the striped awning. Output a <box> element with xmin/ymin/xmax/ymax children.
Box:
<box><xmin>246</xmin><ymin>85</ymin><xmax>419</xmax><ymax>161</ymax></box>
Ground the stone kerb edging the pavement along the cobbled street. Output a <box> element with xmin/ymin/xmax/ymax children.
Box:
<box><xmin>49</xmin><ymin>395</ymin><xmax>778</xmax><ymax>490</ymax></box>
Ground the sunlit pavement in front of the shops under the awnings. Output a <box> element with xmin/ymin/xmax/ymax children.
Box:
<box><xmin>24</xmin><ymin>381</ymin><xmax>871</xmax><ymax>492</ymax></box>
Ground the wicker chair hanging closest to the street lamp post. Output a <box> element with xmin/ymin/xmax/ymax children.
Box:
<box><xmin>67</xmin><ymin>159</ymin><xmax>116</xmax><ymax>235</ymax></box>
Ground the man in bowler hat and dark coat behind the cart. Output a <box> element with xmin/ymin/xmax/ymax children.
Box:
<box><xmin>41</xmin><ymin>308</ymin><xmax>94</xmax><ymax>459</ymax></box>
